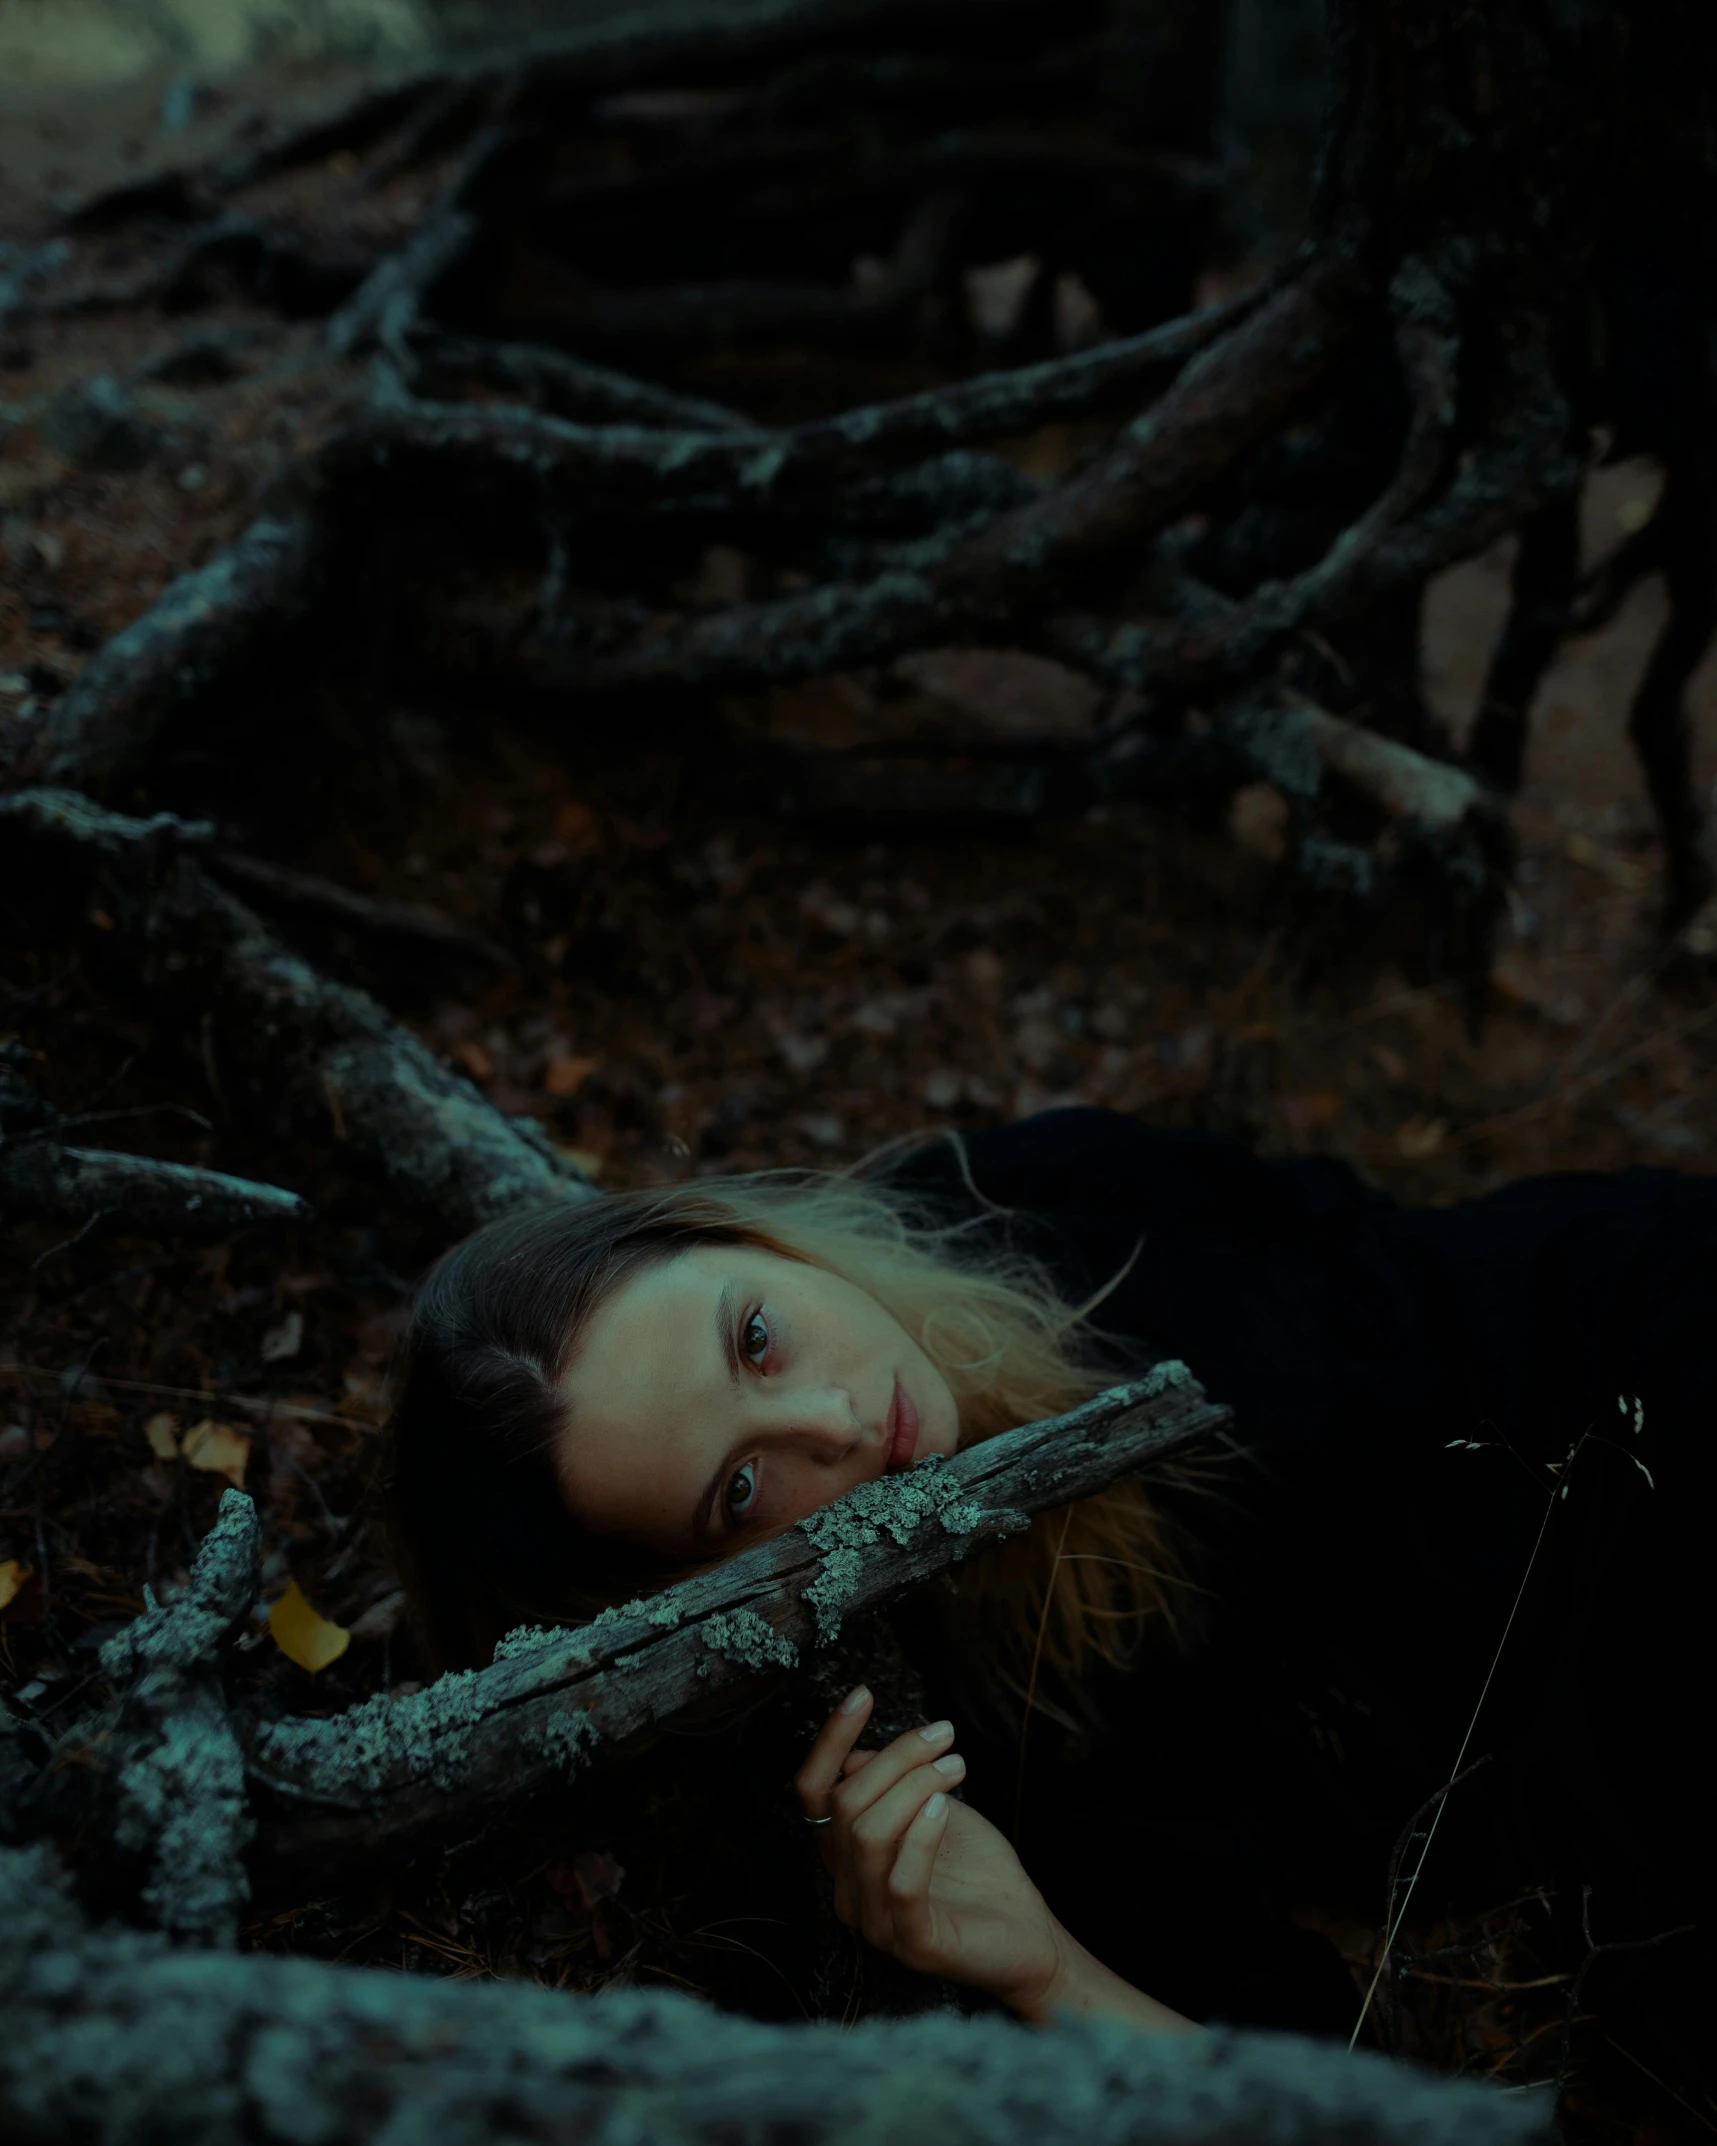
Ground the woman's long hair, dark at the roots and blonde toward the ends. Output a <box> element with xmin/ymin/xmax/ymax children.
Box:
<box><xmin>388</xmin><ymin>1172</ymin><xmax>1180</xmax><ymax>1719</ymax></box>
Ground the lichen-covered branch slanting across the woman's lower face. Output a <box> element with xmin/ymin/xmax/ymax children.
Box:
<box><xmin>245</xmin><ymin>1363</ymin><xmax>1230</xmax><ymax>1888</ymax></box>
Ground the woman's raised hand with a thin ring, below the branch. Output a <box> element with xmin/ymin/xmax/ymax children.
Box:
<box><xmin>794</xmin><ymin>1689</ymin><xmax>1065</xmax><ymax>2017</ymax></box>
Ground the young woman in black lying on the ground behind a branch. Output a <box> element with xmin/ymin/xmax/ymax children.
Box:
<box><xmin>393</xmin><ymin>1109</ymin><xmax>1717</xmax><ymax>2060</ymax></box>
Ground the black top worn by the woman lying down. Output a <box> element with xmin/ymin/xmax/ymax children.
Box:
<box><xmin>891</xmin><ymin>1109</ymin><xmax>1717</xmax><ymax>2032</ymax></box>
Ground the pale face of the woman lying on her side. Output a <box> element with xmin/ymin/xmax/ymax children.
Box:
<box><xmin>556</xmin><ymin>1245</ymin><xmax>959</xmax><ymax>1562</ymax></box>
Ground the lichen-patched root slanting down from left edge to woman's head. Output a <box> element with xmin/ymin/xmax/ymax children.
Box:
<box><xmin>0</xmin><ymin>790</ymin><xmax>592</xmax><ymax>1236</ymax></box>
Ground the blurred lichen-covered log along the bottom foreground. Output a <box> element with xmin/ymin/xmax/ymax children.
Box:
<box><xmin>0</xmin><ymin>1850</ymin><xmax>1547</xmax><ymax>2146</ymax></box>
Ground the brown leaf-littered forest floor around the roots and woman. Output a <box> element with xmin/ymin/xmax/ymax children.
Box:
<box><xmin>0</xmin><ymin>50</ymin><xmax>1717</xmax><ymax>2137</ymax></box>
